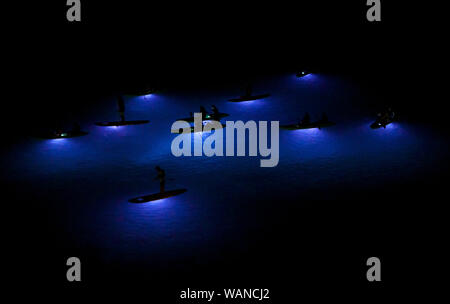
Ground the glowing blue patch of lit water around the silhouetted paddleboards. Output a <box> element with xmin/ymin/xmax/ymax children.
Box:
<box><xmin>2</xmin><ymin>74</ymin><xmax>448</xmax><ymax>264</ymax></box>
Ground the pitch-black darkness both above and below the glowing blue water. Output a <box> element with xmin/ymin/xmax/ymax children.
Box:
<box><xmin>2</xmin><ymin>0</ymin><xmax>448</xmax><ymax>303</ymax></box>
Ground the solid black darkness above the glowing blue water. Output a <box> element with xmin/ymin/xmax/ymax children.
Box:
<box><xmin>5</xmin><ymin>0</ymin><xmax>445</xmax><ymax>133</ymax></box>
